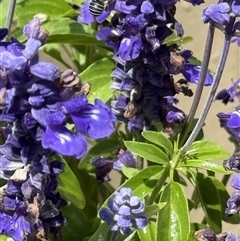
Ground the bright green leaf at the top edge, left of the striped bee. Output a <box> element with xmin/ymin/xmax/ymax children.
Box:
<box><xmin>16</xmin><ymin>0</ymin><xmax>73</xmax><ymax>27</ymax></box>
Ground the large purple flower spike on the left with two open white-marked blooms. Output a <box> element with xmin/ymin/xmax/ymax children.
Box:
<box><xmin>0</xmin><ymin>18</ymin><xmax>116</xmax><ymax>241</ymax></box>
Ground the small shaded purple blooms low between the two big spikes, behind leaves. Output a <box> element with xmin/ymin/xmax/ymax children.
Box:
<box><xmin>92</xmin><ymin>150</ymin><xmax>137</xmax><ymax>182</ymax></box>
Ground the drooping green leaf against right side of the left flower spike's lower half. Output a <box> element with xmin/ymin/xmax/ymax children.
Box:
<box><xmin>58</xmin><ymin>158</ymin><xmax>85</xmax><ymax>209</ymax></box>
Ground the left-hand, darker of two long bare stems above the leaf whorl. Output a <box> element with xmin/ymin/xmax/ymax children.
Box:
<box><xmin>180</xmin><ymin>22</ymin><xmax>215</xmax><ymax>146</ymax></box>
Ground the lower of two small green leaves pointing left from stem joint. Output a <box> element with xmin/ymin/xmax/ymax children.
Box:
<box><xmin>124</xmin><ymin>141</ymin><xmax>169</xmax><ymax>164</ymax></box>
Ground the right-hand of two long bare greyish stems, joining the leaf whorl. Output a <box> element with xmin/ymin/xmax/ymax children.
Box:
<box><xmin>181</xmin><ymin>35</ymin><xmax>231</xmax><ymax>152</ymax></box>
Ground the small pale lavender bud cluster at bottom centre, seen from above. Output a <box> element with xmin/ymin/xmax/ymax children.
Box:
<box><xmin>99</xmin><ymin>187</ymin><xmax>148</xmax><ymax>235</ymax></box>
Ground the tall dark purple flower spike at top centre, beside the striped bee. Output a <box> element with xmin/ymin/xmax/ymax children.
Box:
<box><xmin>78</xmin><ymin>0</ymin><xmax>212</xmax><ymax>135</ymax></box>
